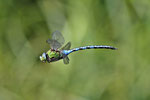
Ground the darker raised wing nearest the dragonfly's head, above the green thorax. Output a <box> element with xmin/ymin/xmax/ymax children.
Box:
<box><xmin>46</xmin><ymin>39</ymin><xmax>61</xmax><ymax>50</ymax></box>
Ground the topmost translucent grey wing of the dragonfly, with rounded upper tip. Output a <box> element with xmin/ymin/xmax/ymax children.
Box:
<box><xmin>52</xmin><ymin>31</ymin><xmax>65</xmax><ymax>45</ymax></box>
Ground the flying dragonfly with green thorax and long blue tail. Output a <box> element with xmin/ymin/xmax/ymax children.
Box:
<box><xmin>40</xmin><ymin>31</ymin><xmax>117</xmax><ymax>64</ymax></box>
